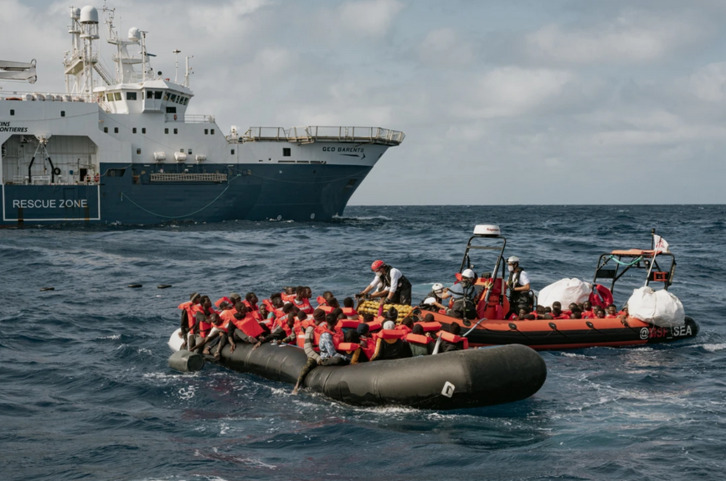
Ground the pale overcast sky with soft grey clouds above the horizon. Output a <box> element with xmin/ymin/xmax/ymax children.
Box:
<box><xmin>0</xmin><ymin>0</ymin><xmax>726</xmax><ymax>205</ymax></box>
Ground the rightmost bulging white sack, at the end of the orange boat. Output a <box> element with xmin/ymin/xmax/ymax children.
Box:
<box><xmin>628</xmin><ymin>286</ymin><xmax>686</xmax><ymax>327</ymax></box>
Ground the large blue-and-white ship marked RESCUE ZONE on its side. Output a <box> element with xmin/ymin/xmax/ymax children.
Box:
<box><xmin>0</xmin><ymin>6</ymin><xmax>404</xmax><ymax>226</ymax></box>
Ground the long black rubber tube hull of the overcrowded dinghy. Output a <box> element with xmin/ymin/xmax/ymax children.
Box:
<box><xmin>219</xmin><ymin>344</ymin><xmax>547</xmax><ymax>409</ymax></box>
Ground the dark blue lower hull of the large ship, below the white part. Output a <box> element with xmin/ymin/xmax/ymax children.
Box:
<box><xmin>2</xmin><ymin>158</ymin><xmax>371</xmax><ymax>226</ymax></box>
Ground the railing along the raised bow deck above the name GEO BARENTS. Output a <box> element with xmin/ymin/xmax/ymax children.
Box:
<box><xmin>239</xmin><ymin>125</ymin><xmax>405</xmax><ymax>145</ymax></box>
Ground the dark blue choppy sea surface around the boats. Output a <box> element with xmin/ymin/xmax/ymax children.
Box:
<box><xmin>0</xmin><ymin>205</ymin><xmax>726</xmax><ymax>481</ymax></box>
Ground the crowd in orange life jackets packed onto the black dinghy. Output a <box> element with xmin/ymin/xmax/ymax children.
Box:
<box><xmin>179</xmin><ymin>263</ymin><xmax>469</xmax><ymax>392</ymax></box>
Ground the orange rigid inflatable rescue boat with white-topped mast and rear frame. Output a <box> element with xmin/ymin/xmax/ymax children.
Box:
<box><xmin>422</xmin><ymin>225</ymin><xmax>698</xmax><ymax>350</ymax></box>
